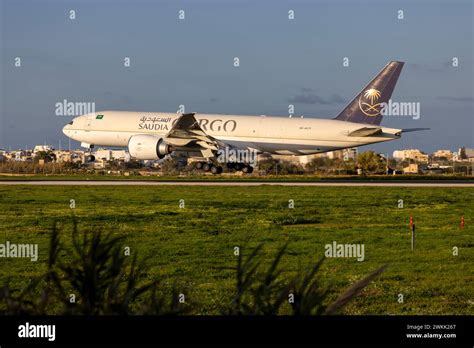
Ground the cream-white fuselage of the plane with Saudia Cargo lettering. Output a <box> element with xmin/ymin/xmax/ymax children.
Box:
<box><xmin>63</xmin><ymin>111</ymin><xmax>401</xmax><ymax>155</ymax></box>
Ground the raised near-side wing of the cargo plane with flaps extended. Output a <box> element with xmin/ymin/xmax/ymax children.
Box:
<box><xmin>166</xmin><ymin>113</ymin><xmax>226</xmax><ymax>155</ymax></box>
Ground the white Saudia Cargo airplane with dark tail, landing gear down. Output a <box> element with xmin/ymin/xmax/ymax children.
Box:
<box><xmin>63</xmin><ymin>61</ymin><xmax>427</xmax><ymax>174</ymax></box>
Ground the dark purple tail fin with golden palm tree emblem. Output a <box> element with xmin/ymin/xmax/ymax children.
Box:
<box><xmin>335</xmin><ymin>61</ymin><xmax>404</xmax><ymax>125</ymax></box>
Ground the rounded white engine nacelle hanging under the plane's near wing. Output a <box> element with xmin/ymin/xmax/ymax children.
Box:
<box><xmin>128</xmin><ymin>134</ymin><xmax>172</xmax><ymax>160</ymax></box>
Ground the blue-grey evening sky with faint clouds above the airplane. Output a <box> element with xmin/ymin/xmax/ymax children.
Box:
<box><xmin>0</xmin><ymin>0</ymin><xmax>474</xmax><ymax>153</ymax></box>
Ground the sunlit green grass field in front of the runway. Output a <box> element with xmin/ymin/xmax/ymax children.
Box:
<box><xmin>0</xmin><ymin>186</ymin><xmax>474</xmax><ymax>315</ymax></box>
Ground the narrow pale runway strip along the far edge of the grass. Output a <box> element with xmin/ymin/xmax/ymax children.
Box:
<box><xmin>0</xmin><ymin>180</ymin><xmax>474</xmax><ymax>188</ymax></box>
